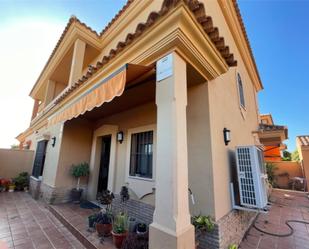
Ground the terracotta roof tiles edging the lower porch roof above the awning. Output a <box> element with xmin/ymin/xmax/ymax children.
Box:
<box><xmin>55</xmin><ymin>0</ymin><xmax>237</xmax><ymax>104</ymax></box>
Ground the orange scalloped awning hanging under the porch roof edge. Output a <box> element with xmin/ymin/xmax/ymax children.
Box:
<box><xmin>48</xmin><ymin>64</ymin><xmax>152</xmax><ymax>125</ymax></box>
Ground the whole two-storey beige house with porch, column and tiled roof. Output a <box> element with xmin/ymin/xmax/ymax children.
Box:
<box><xmin>18</xmin><ymin>0</ymin><xmax>262</xmax><ymax>249</ymax></box>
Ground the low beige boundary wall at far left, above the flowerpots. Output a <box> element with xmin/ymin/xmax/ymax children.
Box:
<box><xmin>0</xmin><ymin>149</ymin><xmax>33</xmax><ymax>178</ymax></box>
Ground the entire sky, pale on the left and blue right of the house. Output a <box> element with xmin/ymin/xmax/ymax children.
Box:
<box><xmin>0</xmin><ymin>0</ymin><xmax>309</xmax><ymax>151</ymax></box>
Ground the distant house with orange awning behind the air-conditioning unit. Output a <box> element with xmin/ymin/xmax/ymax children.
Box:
<box><xmin>258</xmin><ymin>114</ymin><xmax>288</xmax><ymax>162</ymax></box>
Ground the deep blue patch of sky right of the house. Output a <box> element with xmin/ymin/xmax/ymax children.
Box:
<box><xmin>239</xmin><ymin>1</ymin><xmax>309</xmax><ymax>150</ymax></box>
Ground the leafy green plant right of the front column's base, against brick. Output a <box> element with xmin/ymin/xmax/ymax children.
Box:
<box><xmin>192</xmin><ymin>215</ymin><xmax>215</xmax><ymax>248</ymax></box>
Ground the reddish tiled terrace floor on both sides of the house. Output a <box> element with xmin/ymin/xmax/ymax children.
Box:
<box><xmin>0</xmin><ymin>190</ymin><xmax>309</xmax><ymax>249</ymax></box>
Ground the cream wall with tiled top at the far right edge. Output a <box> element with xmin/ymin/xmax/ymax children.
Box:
<box><xmin>296</xmin><ymin>135</ymin><xmax>309</xmax><ymax>189</ymax></box>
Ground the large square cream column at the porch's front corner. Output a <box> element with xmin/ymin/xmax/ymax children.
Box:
<box><xmin>149</xmin><ymin>52</ymin><xmax>195</xmax><ymax>249</ymax></box>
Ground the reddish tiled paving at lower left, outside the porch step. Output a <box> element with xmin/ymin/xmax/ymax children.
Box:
<box><xmin>0</xmin><ymin>192</ymin><xmax>85</xmax><ymax>249</ymax></box>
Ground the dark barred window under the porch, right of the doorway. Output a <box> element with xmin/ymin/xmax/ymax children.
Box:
<box><xmin>130</xmin><ymin>131</ymin><xmax>153</xmax><ymax>178</ymax></box>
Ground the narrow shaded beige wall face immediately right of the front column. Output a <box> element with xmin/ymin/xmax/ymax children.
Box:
<box><xmin>187</xmin><ymin>83</ymin><xmax>215</xmax><ymax>215</ymax></box>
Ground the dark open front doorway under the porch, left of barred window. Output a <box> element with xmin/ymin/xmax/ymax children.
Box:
<box><xmin>97</xmin><ymin>135</ymin><xmax>112</xmax><ymax>192</ymax></box>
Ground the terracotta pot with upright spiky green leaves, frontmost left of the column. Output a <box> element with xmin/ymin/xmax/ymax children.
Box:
<box><xmin>112</xmin><ymin>213</ymin><xmax>128</xmax><ymax>248</ymax></box>
